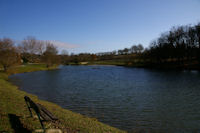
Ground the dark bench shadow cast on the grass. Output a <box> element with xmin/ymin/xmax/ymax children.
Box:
<box><xmin>8</xmin><ymin>114</ymin><xmax>31</xmax><ymax>133</ymax></box>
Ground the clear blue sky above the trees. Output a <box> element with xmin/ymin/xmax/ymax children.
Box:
<box><xmin>0</xmin><ymin>0</ymin><xmax>200</xmax><ymax>53</ymax></box>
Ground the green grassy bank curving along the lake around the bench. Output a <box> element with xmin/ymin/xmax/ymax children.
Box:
<box><xmin>0</xmin><ymin>64</ymin><xmax>124</xmax><ymax>133</ymax></box>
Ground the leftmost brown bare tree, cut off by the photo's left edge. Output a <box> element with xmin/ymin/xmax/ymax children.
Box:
<box><xmin>0</xmin><ymin>38</ymin><xmax>19</xmax><ymax>71</ymax></box>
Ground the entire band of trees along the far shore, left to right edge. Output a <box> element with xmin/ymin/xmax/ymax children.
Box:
<box><xmin>0</xmin><ymin>23</ymin><xmax>200</xmax><ymax>71</ymax></box>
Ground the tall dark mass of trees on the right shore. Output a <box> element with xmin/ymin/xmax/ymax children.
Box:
<box><xmin>143</xmin><ymin>23</ymin><xmax>200</xmax><ymax>66</ymax></box>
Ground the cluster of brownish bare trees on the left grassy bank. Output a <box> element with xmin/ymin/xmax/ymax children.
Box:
<box><xmin>0</xmin><ymin>37</ymin><xmax>60</xmax><ymax>71</ymax></box>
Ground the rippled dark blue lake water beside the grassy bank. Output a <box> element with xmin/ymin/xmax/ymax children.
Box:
<box><xmin>9</xmin><ymin>66</ymin><xmax>200</xmax><ymax>132</ymax></box>
